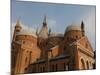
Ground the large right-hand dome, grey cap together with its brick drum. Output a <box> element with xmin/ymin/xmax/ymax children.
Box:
<box><xmin>64</xmin><ymin>24</ymin><xmax>82</xmax><ymax>42</ymax></box>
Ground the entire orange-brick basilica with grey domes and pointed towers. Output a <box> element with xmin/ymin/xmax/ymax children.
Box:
<box><xmin>11</xmin><ymin>16</ymin><xmax>96</xmax><ymax>75</ymax></box>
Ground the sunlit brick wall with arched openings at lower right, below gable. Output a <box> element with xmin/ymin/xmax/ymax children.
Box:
<box><xmin>78</xmin><ymin>50</ymin><xmax>95</xmax><ymax>70</ymax></box>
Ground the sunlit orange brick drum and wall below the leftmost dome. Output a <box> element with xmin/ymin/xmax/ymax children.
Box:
<box><xmin>15</xmin><ymin>35</ymin><xmax>41</xmax><ymax>74</ymax></box>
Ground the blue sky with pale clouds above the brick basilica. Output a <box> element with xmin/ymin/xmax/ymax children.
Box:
<box><xmin>11</xmin><ymin>0</ymin><xmax>96</xmax><ymax>50</ymax></box>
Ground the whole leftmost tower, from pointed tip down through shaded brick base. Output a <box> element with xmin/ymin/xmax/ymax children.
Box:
<box><xmin>11</xmin><ymin>20</ymin><xmax>22</xmax><ymax>75</ymax></box>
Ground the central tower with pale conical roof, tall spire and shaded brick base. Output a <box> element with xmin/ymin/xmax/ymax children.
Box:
<box><xmin>36</xmin><ymin>16</ymin><xmax>49</xmax><ymax>58</ymax></box>
